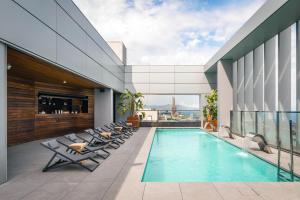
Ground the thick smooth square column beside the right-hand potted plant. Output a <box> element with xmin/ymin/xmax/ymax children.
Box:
<box><xmin>217</xmin><ymin>60</ymin><xmax>233</xmax><ymax>126</ymax></box>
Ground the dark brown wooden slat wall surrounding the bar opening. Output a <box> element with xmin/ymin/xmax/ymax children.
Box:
<box><xmin>7</xmin><ymin>75</ymin><xmax>94</xmax><ymax>145</ymax></box>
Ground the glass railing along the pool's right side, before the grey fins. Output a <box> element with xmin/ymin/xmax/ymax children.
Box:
<box><xmin>230</xmin><ymin>111</ymin><xmax>300</xmax><ymax>153</ymax></box>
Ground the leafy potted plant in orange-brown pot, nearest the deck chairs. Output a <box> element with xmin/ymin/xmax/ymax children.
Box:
<box><xmin>117</xmin><ymin>89</ymin><xmax>144</xmax><ymax>127</ymax></box>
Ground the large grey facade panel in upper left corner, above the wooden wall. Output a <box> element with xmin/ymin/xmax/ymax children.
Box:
<box><xmin>0</xmin><ymin>0</ymin><xmax>56</xmax><ymax>61</ymax></box>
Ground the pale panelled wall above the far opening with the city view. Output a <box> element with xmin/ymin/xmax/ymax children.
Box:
<box><xmin>125</xmin><ymin>65</ymin><xmax>217</xmax><ymax>94</ymax></box>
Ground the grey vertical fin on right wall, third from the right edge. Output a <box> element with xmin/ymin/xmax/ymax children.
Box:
<box><xmin>264</xmin><ymin>35</ymin><xmax>278</xmax><ymax>145</ymax></box>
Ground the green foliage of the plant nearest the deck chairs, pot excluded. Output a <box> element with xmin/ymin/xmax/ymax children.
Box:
<box><xmin>117</xmin><ymin>89</ymin><xmax>144</xmax><ymax>116</ymax></box>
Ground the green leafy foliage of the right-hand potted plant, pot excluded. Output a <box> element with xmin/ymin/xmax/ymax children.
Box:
<box><xmin>203</xmin><ymin>90</ymin><xmax>218</xmax><ymax>120</ymax></box>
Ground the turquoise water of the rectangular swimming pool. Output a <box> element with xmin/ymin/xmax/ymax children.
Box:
<box><xmin>142</xmin><ymin>129</ymin><xmax>298</xmax><ymax>182</ymax></box>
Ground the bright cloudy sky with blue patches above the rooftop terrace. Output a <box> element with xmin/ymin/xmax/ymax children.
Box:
<box><xmin>73</xmin><ymin>0</ymin><xmax>265</xmax><ymax>65</ymax></box>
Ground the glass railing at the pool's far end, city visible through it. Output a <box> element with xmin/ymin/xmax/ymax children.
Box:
<box><xmin>137</xmin><ymin>110</ymin><xmax>202</xmax><ymax>122</ymax></box>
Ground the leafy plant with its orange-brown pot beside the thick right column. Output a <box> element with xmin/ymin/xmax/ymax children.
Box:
<box><xmin>203</xmin><ymin>90</ymin><xmax>218</xmax><ymax>131</ymax></box>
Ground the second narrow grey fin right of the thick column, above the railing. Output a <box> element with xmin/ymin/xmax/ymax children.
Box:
<box><xmin>237</xmin><ymin>57</ymin><xmax>245</xmax><ymax>111</ymax></box>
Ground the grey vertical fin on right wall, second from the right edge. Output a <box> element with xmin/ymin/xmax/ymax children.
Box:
<box><xmin>278</xmin><ymin>27</ymin><xmax>292</xmax><ymax>149</ymax></box>
